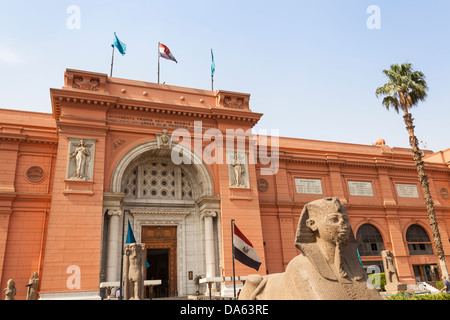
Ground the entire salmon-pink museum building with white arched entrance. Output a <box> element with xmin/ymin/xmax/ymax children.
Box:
<box><xmin>0</xmin><ymin>69</ymin><xmax>450</xmax><ymax>299</ymax></box>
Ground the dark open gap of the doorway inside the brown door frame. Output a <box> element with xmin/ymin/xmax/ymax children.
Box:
<box><xmin>147</xmin><ymin>249</ymin><xmax>170</xmax><ymax>298</ymax></box>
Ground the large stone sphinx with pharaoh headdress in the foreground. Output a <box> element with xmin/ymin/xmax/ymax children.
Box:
<box><xmin>239</xmin><ymin>198</ymin><xmax>382</xmax><ymax>300</ymax></box>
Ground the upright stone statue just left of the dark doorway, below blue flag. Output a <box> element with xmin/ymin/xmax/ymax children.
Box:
<box><xmin>123</xmin><ymin>243</ymin><xmax>145</xmax><ymax>300</ymax></box>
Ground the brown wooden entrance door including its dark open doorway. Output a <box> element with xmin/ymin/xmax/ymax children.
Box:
<box><xmin>141</xmin><ymin>226</ymin><xmax>177</xmax><ymax>297</ymax></box>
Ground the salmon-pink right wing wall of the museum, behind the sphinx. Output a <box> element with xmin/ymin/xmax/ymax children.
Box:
<box><xmin>259</xmin><ymin>138</ymin><xmax>450</xmax><ymax>284</ymax></box>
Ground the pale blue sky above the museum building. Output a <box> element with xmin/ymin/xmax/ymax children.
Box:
<box><xmin>0</xmin><ymin>0</ymin><xmax>450</xmax><ymax>152</ymax></box>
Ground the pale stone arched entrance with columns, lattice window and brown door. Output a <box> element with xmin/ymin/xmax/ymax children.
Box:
<box><xmin>103</xmin><ymin>141</ymin><xmax>220</xmax><ymax>296</ymax></box>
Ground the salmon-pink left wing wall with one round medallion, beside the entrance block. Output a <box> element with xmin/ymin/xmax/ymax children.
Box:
<box><xmin>0</xmin><ymin>110</ymin><xmax>57</xmax><ymax>299</ymax></box>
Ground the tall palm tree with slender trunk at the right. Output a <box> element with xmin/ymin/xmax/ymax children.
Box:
<box><xmin>376</xmin><ymin>63</ymin><xmax>448</xmax><ymax>279</ymax></box>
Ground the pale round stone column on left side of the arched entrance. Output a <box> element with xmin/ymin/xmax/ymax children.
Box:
<box><xmin>106</xmin><ymin>209</ymin><xmax>122</xmax><ymax>281</ymax></box>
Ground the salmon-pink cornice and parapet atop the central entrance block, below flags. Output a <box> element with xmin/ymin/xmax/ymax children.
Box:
<box><xmin>50</xmin><ymin>69</ymin><xmax>262</xmax><ymax>127</ymax></box>
